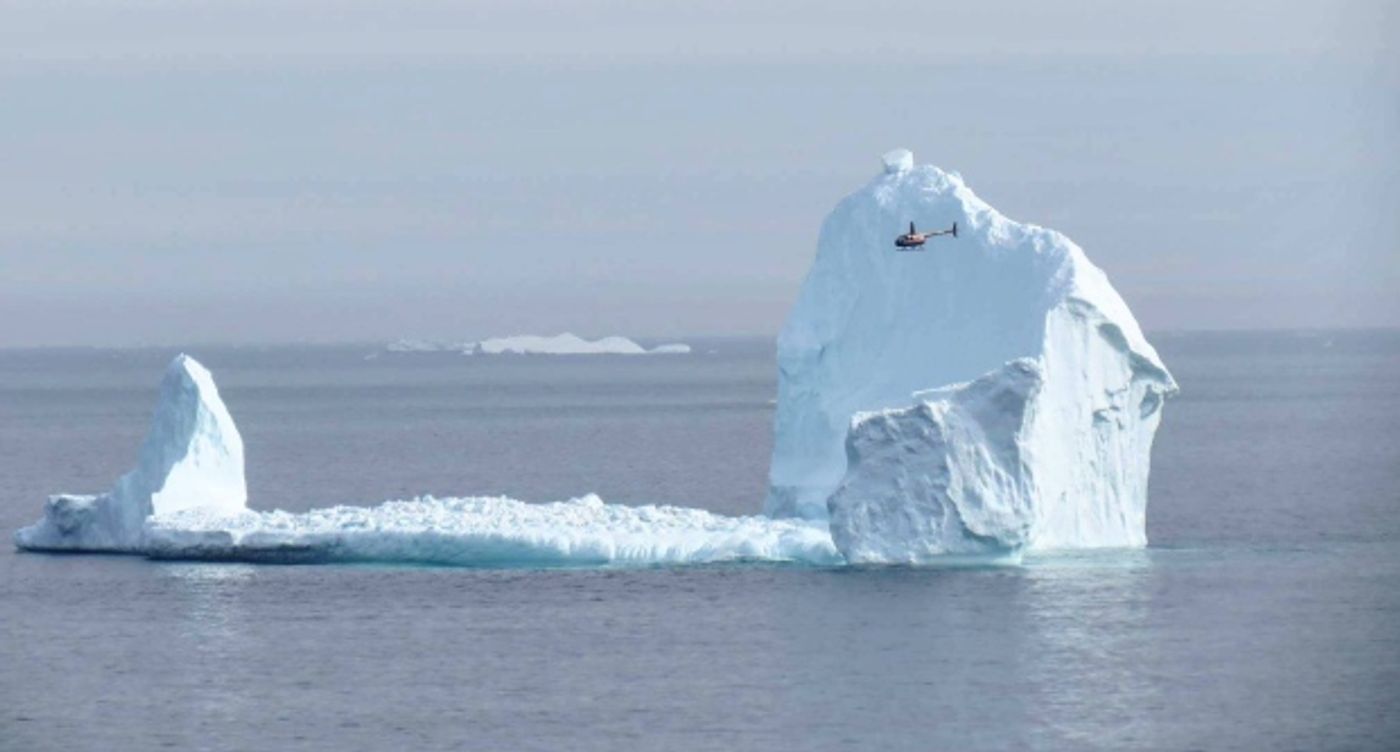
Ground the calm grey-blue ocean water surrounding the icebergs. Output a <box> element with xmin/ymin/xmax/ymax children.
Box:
<box><xmin>0</xmin><ymin>332</ymin><xmax>1400</xmax><ymax>751</ymax></box>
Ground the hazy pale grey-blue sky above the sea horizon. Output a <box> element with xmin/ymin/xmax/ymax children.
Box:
<box><xmin>0</xmin><ymin>0</ymin><xmax>1400</xmax><ymax>346</ymax></box>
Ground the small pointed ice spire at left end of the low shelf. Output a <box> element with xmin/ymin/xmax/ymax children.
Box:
<box><xmin>14</xmin><ymin>354</ymin><xmax>248</xmax><ymax>553</ymax></box>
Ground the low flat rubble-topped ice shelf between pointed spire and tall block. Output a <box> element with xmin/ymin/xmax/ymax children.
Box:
<box><xmin>147</xmin><ymin>496</ymin><xmax>841</xmax><ymax>567</ymax></box>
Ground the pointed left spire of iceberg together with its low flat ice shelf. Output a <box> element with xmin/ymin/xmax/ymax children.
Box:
<box><xmin>14</xmin><ymin>356</ymin><xmax>841</xmax><ymax>566</ymax></box>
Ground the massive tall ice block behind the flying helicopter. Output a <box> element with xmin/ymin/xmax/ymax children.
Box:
<box><xmin>766</xmin><ymin>150</ymin><xmax>1176</xmax><ymax>562</ymax></box>
